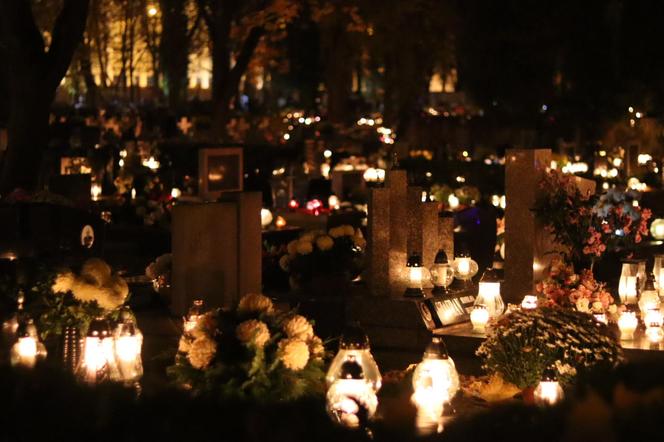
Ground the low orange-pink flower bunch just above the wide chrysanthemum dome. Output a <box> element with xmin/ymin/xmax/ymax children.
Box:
<box><xmin>535</xmin><ymin>256</ymin><xmax>618</xmax><ymax>316</ymax></box>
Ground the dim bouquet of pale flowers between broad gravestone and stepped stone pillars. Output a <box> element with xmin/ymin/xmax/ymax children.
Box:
<box><xmin>279</xmin><ymin>225</ymin><xmax>366</xmax><ymax>294</ymax></box>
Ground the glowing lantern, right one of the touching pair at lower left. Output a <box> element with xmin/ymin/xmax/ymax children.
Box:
<box><xmin>114</xmin><ymin>311</ymin><xmax>143</xmax><ymax>384</ymax></box>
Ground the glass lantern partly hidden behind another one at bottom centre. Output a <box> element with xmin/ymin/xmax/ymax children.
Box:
<box><xmin>325</xmin><ymin>325</ymin><xmax>382</xmax><ymax>392</ymax></box>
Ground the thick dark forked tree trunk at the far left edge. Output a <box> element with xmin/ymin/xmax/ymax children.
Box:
<box><xmin>0</xmin><ymin>0</ymin><xmax>89</xmax><ymax>195</ymax></box>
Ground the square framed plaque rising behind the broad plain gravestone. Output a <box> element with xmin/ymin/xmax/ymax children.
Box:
<box><xmin>198</xmin><ymin>147</ymin><xmax>244</xmax><ymax>199</ymax></box>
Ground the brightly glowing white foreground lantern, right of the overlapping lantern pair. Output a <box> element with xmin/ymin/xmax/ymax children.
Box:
<box><xmin>411</xmin><ymin>336</ymin><xmax>459</xmax><ymax>434</ymax></box>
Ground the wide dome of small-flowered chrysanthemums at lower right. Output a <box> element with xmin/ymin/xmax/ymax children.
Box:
<box><xmin>477</xmin><ymin>307</ymin><xmax>623</xmax><ymax>389</ymax></box>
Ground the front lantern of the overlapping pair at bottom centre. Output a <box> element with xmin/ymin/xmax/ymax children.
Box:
<box><xmin>326</xmin><ymin>357</ymin><xmax>378</xmax><ymax>428</ymax></box>
